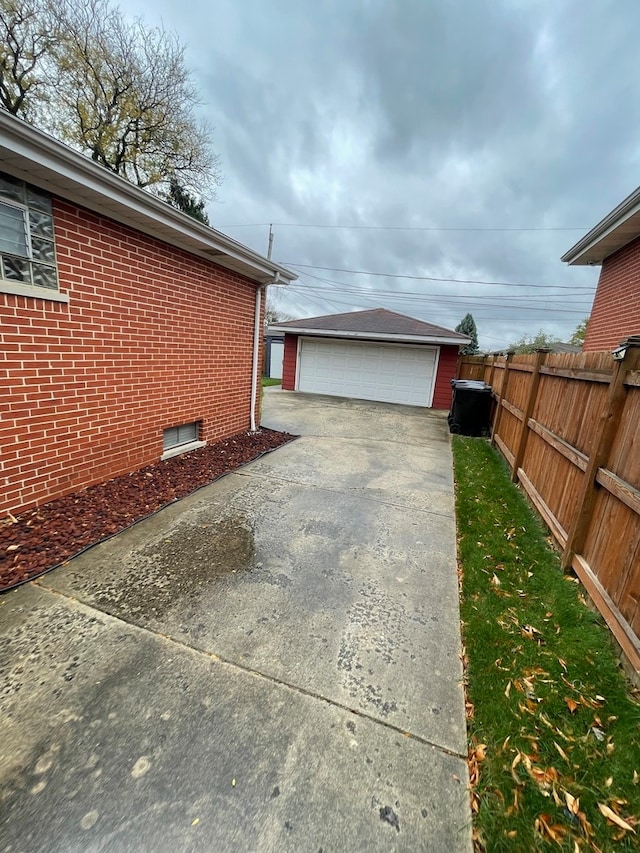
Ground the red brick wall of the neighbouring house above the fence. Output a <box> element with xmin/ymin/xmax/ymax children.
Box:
<box><xmin>583</xmin><ymin>240</ymin><xmax>640</xmax><ymax>351</ymax></box>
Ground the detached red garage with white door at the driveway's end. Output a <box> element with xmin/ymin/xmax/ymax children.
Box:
<box><xmin>269</xmin><ymin>308</ymin><xmax>469</xmax><ymax>409</ymax></box>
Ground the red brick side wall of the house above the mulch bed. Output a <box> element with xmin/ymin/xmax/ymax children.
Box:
<box><xmin>0</xmin><ymin>200</ymin><xmax>255</xmax><ymax>513</ymax></box>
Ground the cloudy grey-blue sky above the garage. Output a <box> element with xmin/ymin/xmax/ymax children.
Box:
<box><xmin>127</xmin><ymin>0</ymin><xmax>640</xmax><ymax>350</ymax></box>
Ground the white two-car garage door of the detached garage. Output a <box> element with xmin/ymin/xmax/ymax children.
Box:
<box><xmin>298</xmin><ymin>338</ymin><xmax>438</xmax><ymax>406</ymax></box>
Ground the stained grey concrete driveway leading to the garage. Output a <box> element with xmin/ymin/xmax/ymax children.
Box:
<box><xmin>0</xmin><ymin>390</ymin><xmax>471</xmax><ymax>853</ymax></box>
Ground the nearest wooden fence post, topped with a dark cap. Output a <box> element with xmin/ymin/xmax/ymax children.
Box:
<box><xmin>562</xmin><ymin>336</ymin><xmax>640</xmax><ymax>571</ymax></box>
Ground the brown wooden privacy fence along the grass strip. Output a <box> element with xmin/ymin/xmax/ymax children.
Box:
<box><xmin>458</xmin><ymin>336</ymin><xmax>640</xmax><ymax>671</ymax></box>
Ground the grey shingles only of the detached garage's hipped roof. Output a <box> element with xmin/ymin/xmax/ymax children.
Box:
<box><xmin>273</xmin><ymin>308</ymin><xmax>469</xmax><ymax>344</ymax></box>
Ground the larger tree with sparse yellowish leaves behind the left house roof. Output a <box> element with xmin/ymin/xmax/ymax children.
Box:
<box><xmin>46</xmin><ymin>0</ymin><xmax>220</xmax><ymax>196</ymax></box>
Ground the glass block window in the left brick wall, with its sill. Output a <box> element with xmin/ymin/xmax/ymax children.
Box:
<box><xmin>0</xmin><ymin>172</ymin><xmax>58</xmax><ymax>290</ymax></box>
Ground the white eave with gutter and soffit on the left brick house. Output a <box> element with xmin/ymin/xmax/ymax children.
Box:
<box><xmin>0</xmin><ymin>110</ymin><xmax>297</xmax><ymax>284</ymax></box>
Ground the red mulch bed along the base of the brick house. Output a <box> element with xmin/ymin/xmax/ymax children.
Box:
<box><xmin>0</xmin><ymin>429</ymin><xmax>296</xmax><ymax>591</ymax></box>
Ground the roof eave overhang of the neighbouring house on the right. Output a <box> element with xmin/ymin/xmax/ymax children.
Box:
<box><xmin>561</xmin><ymin>187</ymin><xmax>640</xmax><ymax>266</ymax></box>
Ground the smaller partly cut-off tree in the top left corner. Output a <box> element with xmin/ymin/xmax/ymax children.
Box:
<box><xmin>0</xmin><ymin>0</ymin><xmax>57</xmax><ymax>118</ymax></box>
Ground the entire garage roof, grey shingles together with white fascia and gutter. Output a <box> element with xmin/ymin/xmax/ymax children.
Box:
<box><xmin>269</xmin><ymin>308</ymin><xmax>471</xmax><ymax>346</ymax></box>
